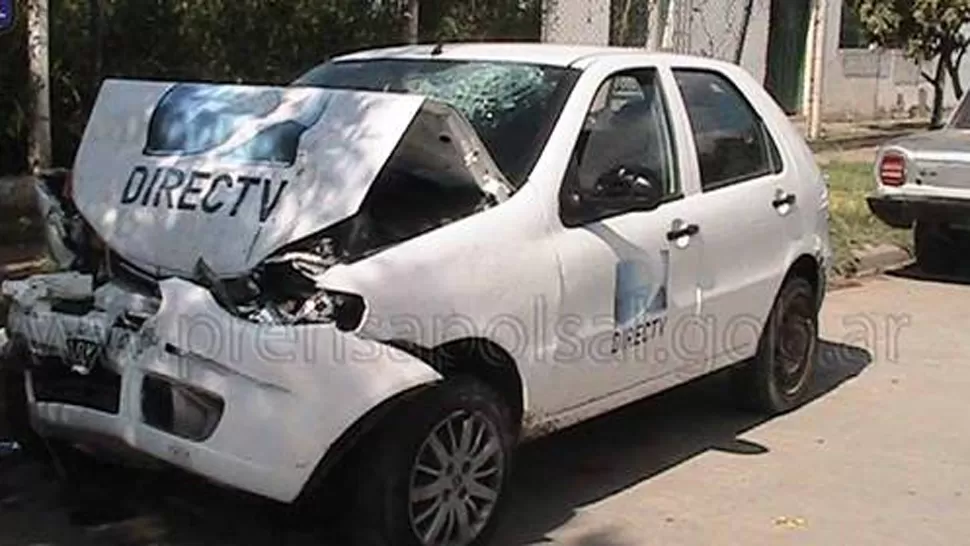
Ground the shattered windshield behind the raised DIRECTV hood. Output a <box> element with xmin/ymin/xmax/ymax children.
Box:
<box><xmin>294</xmin><ymin>59</ymin><xmax>576</xmax><ymax>187</ymax></box>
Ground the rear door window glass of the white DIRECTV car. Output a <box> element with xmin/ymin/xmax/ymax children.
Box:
<box><xmin>674</xmin><ymin>69</ymin><xmax>781</xmax><ymax>191</ymax></box>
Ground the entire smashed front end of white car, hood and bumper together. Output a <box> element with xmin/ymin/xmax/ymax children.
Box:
<box><xmin>2</xmin><ymin>78</ymin><xmax>511</xmax><ymax>501</ymax></box>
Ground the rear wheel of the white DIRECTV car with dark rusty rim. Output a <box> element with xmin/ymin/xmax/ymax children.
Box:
<box><xmin>731</xmin><ymin>277</ymin><xmax>818</xmax><ymax>415</ymax></box>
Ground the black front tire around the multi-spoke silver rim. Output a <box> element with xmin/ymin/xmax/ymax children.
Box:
<box><xmin>352</xmin><ymin>377</ymin><xmax>514</xmax><ymax>546</ymax></box>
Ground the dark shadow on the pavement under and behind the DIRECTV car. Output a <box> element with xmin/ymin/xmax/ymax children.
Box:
<box><xmin>496</xmin><ymin>343</ymin><xmax>872</xmax><ymax>546</ymax></box>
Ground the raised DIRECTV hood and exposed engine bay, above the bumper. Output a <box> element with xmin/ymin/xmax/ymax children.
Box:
<box><xmin>15</xmin><ymin>81</ymin><xmax>513</xmax><ymax>331</ymax></box>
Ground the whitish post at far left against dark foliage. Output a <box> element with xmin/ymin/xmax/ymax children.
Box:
<box><xmin>27</xmin><ymin>0</ymin><xmax>51</xmax><ymax>172</ymax></box>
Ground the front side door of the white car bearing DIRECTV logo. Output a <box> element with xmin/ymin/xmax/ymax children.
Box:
<box><xmin>555</xmin><ymin>68</ymin><xmax>699</xmax><ymax>410</ymax></box>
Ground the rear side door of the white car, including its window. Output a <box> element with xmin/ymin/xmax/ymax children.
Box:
<box><xmin>673</xmin><ymin>67</ymin><xmax>807</xmax><ymax>368</ymax></box>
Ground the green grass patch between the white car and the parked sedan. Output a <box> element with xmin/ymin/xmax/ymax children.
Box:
<box><xmin>823</xmin><ymin>162</ymin><xmax>912</xmax><ymax>276</ymax></box>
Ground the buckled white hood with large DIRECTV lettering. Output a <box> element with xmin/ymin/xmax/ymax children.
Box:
<box><xmin>73</xmin><ymin>80</ymin><xmax>506</xmax><ymax>276</ymax></box>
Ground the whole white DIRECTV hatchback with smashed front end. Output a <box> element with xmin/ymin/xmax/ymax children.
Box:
<box><xmin>3</xmin><ymin>44</ymin><xmax>830</xmax><ymax>546</ymax></box>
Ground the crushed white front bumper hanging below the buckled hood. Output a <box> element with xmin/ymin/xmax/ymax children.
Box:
<box><xmin>4</xmin><ymin>273</ymin><xmax>440</xmax><ymax>502</ymax></box>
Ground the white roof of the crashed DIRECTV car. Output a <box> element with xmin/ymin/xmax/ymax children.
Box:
<box><xmin>333</xmin><ymin>42</ymin><xmax>722</xmax><ymax>69</ymax></box>
